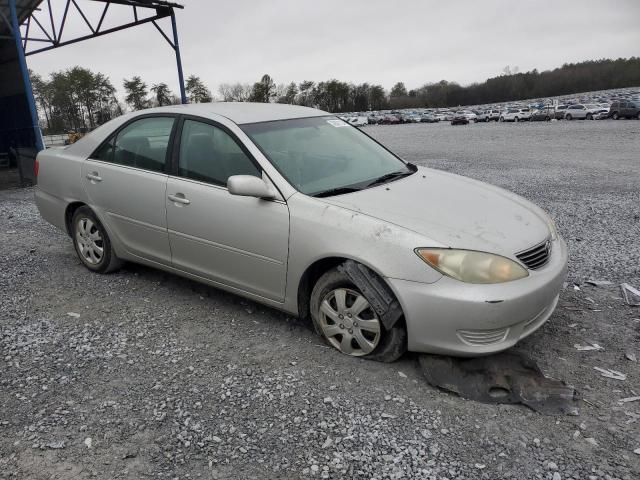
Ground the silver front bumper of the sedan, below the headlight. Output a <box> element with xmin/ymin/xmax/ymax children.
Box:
<box><xmin>387</xmin><ymin>238</ymin><xmax>567</xmax><ymax>356</ymax></box>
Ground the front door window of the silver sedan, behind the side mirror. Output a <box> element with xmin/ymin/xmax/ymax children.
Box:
<box><xmin>178</xmin><ymin>120</ymin><xmax>262</xmax><ymax>186</ymax></box>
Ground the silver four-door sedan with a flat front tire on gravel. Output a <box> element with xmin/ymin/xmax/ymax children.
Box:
<box><xmin>35</xmin><ymin>103</ymin><xmax>567</xmax><ymax>361</ymax></box>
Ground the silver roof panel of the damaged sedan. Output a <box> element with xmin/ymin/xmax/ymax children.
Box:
<box><xmin>143</xmin><ymin>102</ymin><xmax>331</xmax><ymax>125</ymax></box>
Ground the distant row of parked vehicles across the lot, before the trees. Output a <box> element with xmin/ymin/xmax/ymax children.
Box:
<box><xmin>340</xmin><ymin>100</ymin><xmax>640</xmax><ymax>127</ymax></box>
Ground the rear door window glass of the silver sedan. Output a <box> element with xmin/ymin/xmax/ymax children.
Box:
<box><xmin>92</xmin><ymin>117</ymin><xmax>175</xmax><ymax>172</ymax></box>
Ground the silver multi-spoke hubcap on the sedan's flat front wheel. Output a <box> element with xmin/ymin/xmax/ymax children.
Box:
<box><xmin>320</xmin><ymin>288</ymin><xmax>380</xmax><ymax>357</ymax></box>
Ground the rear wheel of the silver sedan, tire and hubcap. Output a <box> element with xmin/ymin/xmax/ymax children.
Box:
<box><xmin>71</xmin><ymin>206</ymin><xmax>122</xmax><ymax>273</ymax></box>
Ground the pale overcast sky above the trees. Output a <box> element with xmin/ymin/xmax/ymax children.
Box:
<box><xmin>27</xmin><ymin>0</ymin><xmax>640</xmax><ymax>94</ymax></box>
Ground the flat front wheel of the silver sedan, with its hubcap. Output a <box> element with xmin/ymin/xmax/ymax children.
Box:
<box><xmin>309</xmin><ymin>268</ymin><xmax>407</xmax><ymax>362</ymax></box>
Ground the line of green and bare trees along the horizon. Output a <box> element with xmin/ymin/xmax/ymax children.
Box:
<box><xmin>31</xmin><ymin>57</ymin><xmax>640</xmax><ymax>133</ymax></box>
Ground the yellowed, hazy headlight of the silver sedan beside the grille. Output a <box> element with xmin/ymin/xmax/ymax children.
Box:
<box><xmin>415</xmin><ymin>248</ymin><xmax>529</xmax><ymax>283</ymax></box>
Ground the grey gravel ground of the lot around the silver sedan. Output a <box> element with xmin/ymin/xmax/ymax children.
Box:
<box><xmin>0</xmin><ymin>121</ymin><xmax>640</xmax><ymax>480</ymax></box>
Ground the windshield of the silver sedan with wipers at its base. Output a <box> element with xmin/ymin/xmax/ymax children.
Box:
<box><xmin>240</xmin><ymin>116</ymin><xmax>413</xmax><ymax>195</ymax></box>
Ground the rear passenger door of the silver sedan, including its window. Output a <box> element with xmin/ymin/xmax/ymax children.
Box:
<box><xmin>82</xmin><ymin>115</ymin><xmax>176</xmax><ymax>265</ymax></box>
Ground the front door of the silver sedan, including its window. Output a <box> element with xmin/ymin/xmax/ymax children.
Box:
<box><xmin>166</xmin><ymin>119</ymin><xmax>289</xmax><ymax>301</ymax></box>
